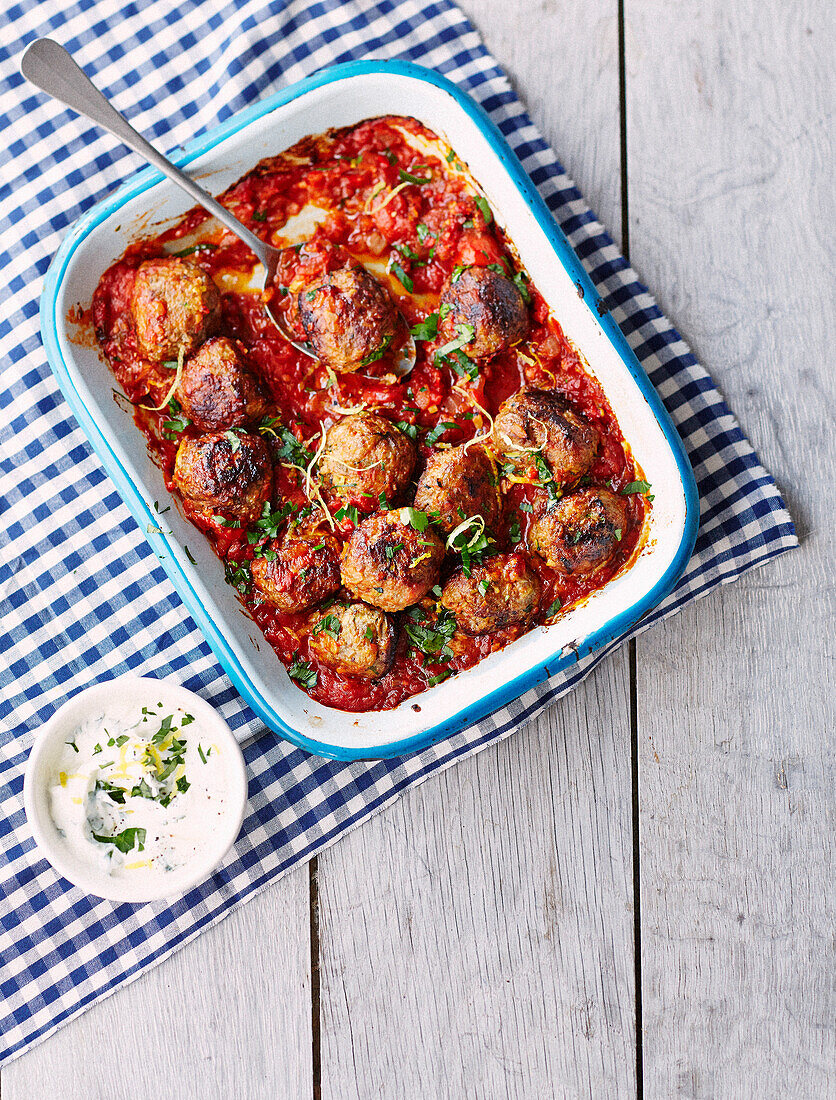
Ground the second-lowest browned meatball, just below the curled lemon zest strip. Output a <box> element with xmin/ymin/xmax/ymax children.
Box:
<box><xmin>441</xmin><ymin>553</ymin><xmax>540</xmax><ymax>634</ymax></box>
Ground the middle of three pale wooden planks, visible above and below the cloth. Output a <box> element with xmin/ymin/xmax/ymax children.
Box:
<box><xmin>319</xmin><ymin>0</ymin><xmax>635</xmax><ymax>1100</ymax></box>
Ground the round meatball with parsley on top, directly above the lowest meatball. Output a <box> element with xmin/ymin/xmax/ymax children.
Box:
<box><xmin>342</xmin><ymin>509</ymin><xmax>444</xmax><ymax>612</ymax></box>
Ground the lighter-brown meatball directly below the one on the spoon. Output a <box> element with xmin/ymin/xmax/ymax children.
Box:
<box><xmin>319</xmin><ymin>413</ymin><xmax>417</xmax><ymax>512</ymax></box>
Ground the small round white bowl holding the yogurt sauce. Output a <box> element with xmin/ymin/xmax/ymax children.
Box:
<box><xmin>23</xmin><ymin>677</ymin><xmax>248</xmax><ymax>902</ymax></box>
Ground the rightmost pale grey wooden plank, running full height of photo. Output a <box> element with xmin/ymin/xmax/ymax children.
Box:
<box><xmin>626</xmin><ymin>0</ymin><xmax>836</xmax><ymax>1100</ymax></box>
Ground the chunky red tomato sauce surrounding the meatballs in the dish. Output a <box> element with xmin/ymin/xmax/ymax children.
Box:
<box><xmin>92</xmin><ymin>117</ymin><xmax>649</xmax><ymax>712</ymax></box>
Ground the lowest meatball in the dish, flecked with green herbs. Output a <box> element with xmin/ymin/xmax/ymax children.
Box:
<box><xmin>309</xmin><ymin>603</ymin><xmax>396</xmax><ymax>680</ymax></box>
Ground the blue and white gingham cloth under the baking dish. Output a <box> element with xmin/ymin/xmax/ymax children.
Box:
<box><xmin>0</xmin><ymin>0</ymin><xmax>796</xmax><ymax>1062</ymax></box>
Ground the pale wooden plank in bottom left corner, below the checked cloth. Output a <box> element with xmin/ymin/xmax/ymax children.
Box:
<box><xmin>0</xmin><ymin>867</ymin><xmax>311</xmax><ymax>1100</ymax></box>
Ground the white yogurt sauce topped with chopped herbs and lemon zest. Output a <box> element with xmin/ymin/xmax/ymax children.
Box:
<box><xmin>50</xmin><ymin>696</ymin><xmax>230</xmax><ymax>882</ymax></box>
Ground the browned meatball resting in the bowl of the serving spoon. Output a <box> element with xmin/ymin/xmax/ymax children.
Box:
<box><xmin>297</xmin><ymin>266</ymin><xmax>398</xmax><ymax>371</ymax></box>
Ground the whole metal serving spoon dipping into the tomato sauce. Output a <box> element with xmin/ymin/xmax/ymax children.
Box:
<box><xmin>20</xmin><ymin>39</ymin><xmax>416</xmax><ymax>378</ymax></box>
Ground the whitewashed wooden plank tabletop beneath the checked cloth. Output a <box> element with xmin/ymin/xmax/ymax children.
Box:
<box><xmin>0</xmin><ymin>0</ymin><xmax>836</xmax><ymax>1100</ymax></box>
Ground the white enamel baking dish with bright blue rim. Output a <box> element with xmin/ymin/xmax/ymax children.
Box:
<box><xmin>41</xmin><ymin>62</ymin><xmax>699</xmax><ymax>759</ymax></box>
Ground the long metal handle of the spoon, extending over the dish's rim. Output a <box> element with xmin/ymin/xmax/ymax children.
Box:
<box><xmin>20</xmin><ymin>39</ymin><xmax>273</xmax><ymax>267</ymax></box>
